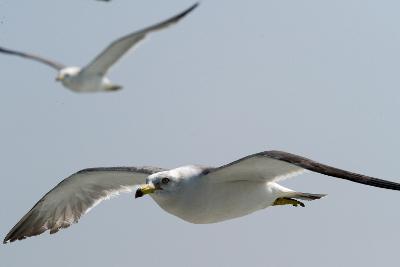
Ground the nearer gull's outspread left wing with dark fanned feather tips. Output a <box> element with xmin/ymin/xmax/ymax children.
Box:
<box><xmin>3</xmin><ymin>167</ymin><xmax>163</xmax><ymax>243</ymax></box>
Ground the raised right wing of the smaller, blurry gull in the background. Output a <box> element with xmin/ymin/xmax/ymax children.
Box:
<box><xmin>82</xmin><ymin>3</ymin><xmax>199</xmax><ymax>75</ymax></box>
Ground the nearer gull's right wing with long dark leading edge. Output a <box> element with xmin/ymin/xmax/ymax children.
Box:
<box><xmin>205</xmin><ymin>151</ymin><xmax>400</xmax><ymax>190</ymax></box>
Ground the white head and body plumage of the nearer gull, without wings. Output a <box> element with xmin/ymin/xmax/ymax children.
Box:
<box><xmin>148</xmin><ymin>165</ymin><xmax>291</xmax><ymax>224</ymax></box>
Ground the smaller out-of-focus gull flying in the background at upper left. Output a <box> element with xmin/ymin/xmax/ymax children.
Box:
<box><xmin>0</xmin><ymin>3</ymin><xmax>199</xmax><ymax>92</ymax></box>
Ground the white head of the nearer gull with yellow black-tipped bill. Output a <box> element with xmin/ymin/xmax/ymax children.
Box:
<box><xmin>135</xmin><ymin>166</ymin><xmax>202</xmax><ymax>198</ymax></box>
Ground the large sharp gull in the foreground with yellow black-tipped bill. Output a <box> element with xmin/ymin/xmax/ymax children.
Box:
<box><xmin>4</xmin><ymin>151</ymin><xmax>400</xmax><ymax>243</ymax></box>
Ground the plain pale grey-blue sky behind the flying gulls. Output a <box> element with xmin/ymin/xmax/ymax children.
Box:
<box><xmin>0</xmin><ymin>0</ymin><xmax>400</xmax><ymax>267</ymax></box>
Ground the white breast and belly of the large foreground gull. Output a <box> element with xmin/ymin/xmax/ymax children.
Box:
<box><xmin>152</xmin><ymin>177</ymin><xmax>279</xmax><ymax>224</ymax></box>
